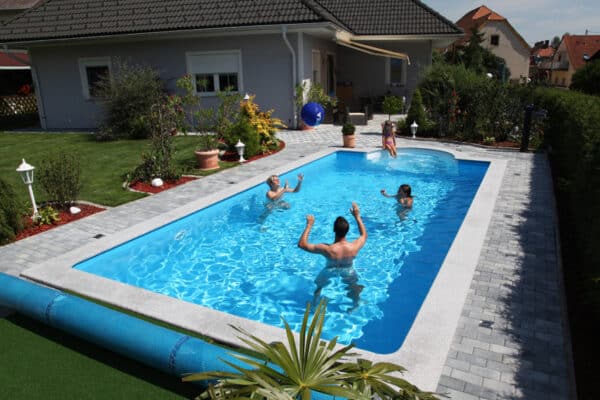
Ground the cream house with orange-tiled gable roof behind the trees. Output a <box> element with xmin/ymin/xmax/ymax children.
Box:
<box><xmin>456</xmin><ymin>6</ymin><xmax>530</xmax><ymax>81</ymax></box>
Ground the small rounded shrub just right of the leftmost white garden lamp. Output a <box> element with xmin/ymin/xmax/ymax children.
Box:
<box><xmin>38</xmin><ymin>152</ymin><xmax>81</xmax><ymax>209</ymax></box>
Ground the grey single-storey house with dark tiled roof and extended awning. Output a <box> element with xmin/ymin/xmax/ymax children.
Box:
<box><xmin>0</xmin><ymin>0</ymin><xmax>462</xmax><ymax>129</ymax></box>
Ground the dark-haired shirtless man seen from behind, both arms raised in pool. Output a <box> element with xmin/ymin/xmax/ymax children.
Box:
<box><xmin>298</xmin><ymin>202</ymin><xmax>367</xmax><ymax>309</ymax></box>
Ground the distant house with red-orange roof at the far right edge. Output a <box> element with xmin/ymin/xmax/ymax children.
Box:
<box><xmin>550</xmin><ymin>35</ymin><xmax>600</xmax><ymax>87</ymax></box>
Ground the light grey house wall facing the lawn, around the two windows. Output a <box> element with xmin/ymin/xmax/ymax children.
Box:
<box><xmin>30</xmin><ymin>35</ymin><xmax>295</xmax><ymax>129</ymax></box>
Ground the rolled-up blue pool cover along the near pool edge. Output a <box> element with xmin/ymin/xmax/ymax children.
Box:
<box><xmin>0</xmin><ymin>272</ymin><xmax>334</xmax><ymax>400</ymax></box>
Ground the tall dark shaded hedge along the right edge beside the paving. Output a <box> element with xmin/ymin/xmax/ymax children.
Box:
<box><xmin>533</xmin><ymin>88</ymin><xmax>600</xmax><ymax>398</ymax></box>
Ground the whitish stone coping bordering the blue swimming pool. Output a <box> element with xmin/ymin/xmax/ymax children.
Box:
<box><xmin>21</xmin><ymin>144</ymin><xmax>507</xmax><ymax>391</ymax></box>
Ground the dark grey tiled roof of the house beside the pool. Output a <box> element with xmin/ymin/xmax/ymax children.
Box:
<box><xmin>0</xmin><ymin>0</ymin><xmax>462</xmax><ymax>43</ymax></box>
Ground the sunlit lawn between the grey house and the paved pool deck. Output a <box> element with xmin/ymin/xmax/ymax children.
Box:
<box><xmin>0</xmin><ymin>132</ymin><xmax>230</xmax><ymax>206</ymax></box>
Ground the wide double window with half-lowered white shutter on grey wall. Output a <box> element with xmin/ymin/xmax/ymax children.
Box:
<box><xmin>186</xmin><ymin>50</ymin><xmax>243</xmax><ymax>96</ymax></box>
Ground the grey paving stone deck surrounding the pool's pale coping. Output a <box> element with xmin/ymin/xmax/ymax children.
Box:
<box><xmin>0</xmin><ymin>116</ymin><xmax>575</xmax><ymax>400</ymax></box>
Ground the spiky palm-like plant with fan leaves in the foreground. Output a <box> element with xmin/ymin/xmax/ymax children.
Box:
<box><xmin>183</xmin><ymin>301</ymin><xmax>435</xmax><ymax>400</ymax></box>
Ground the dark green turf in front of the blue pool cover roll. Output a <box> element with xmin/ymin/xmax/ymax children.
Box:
<box><xmin>0</xmin><ymin>314</ymin><xmax>200</xmax><ymax>400</ymax></box>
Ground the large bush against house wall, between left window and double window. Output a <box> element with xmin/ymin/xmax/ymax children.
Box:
<box><xmin>97</xmin><ymin>61</ymin><xmax>164</xmax><ymax>140</ymax></box>
